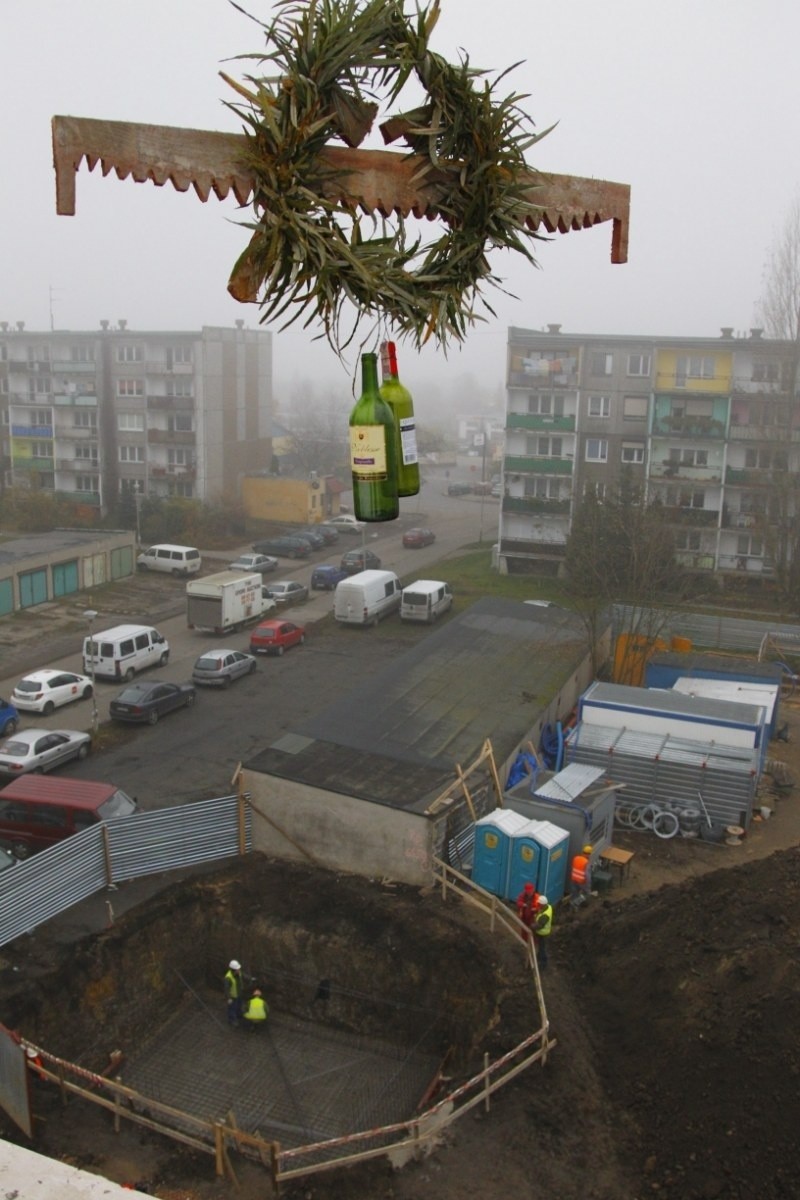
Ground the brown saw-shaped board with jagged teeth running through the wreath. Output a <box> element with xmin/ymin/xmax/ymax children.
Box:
<box><xmin>53</xmin><ymin>116</ymin><xmax>631</xmax><ymax>263</ymax></box>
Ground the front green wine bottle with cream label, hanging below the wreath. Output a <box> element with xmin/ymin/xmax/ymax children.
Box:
<box><xmin>350</xmin><ymin>354</ymin><xmax>399</xmax><ymax>521</ymax></box>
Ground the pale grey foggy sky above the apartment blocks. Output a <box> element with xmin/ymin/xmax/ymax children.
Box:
<box><xmin>0</xmin><ymin>0</ymin><xmax>800</xmax><ymax>412</ymax></box>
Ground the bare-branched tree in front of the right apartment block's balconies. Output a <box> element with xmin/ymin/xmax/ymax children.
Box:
<box><xmin>565</xmin><ymin>473</ymin><xmax>682</xmax><ymax>683</ymax></box>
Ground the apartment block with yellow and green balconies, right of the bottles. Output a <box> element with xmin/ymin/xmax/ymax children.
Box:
<box><xmin>499</xmin><ymin>325</ymin><xmax>800</xmax><ymax>576</ymax></box>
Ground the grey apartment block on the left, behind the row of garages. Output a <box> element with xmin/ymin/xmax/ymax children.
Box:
<box><xmin>0</xmin><ymin>320</ymin><xmax>272</xmax><ymax>514</ymax></box>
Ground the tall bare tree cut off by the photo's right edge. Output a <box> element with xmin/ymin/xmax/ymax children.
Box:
<box><xmin>757</xmin><ymin>196</ymin><xmax>800</xmax><ymax>612</ymax></box>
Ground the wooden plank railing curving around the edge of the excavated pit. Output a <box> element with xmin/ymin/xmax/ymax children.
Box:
<box><xmin>0</xmin><ymin>859</ymin><xmax>557</xmax><ymax>1192</ymax></box>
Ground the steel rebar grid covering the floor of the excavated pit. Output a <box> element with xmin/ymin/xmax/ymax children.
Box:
<box><xmin>124</xmin><ymin>997</ymin><xmax>438</xmax><ymax>1146</ymax></box>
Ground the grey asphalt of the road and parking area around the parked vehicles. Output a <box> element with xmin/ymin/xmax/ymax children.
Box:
<box><xmin>0</xmin><ymin>480</ymin><xmax>498</xmax><ymax>809</ymax></box>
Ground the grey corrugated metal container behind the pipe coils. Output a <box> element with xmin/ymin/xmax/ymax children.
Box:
<box><xmin>566</xmin><ymin>724</ymin><xmax>758</xmax><ymax>828</ymax></box>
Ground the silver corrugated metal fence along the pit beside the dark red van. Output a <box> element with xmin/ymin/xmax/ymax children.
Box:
<box><xmin>0</xmin><ymin>793</ymin><xmax>252</xmax><ymax>946</ymax></box>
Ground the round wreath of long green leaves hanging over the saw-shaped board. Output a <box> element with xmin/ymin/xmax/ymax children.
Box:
<box><xmin>223</xmin><ymin>0</ymin><xmax>549</xmax><ymax>354</ymax></box>
